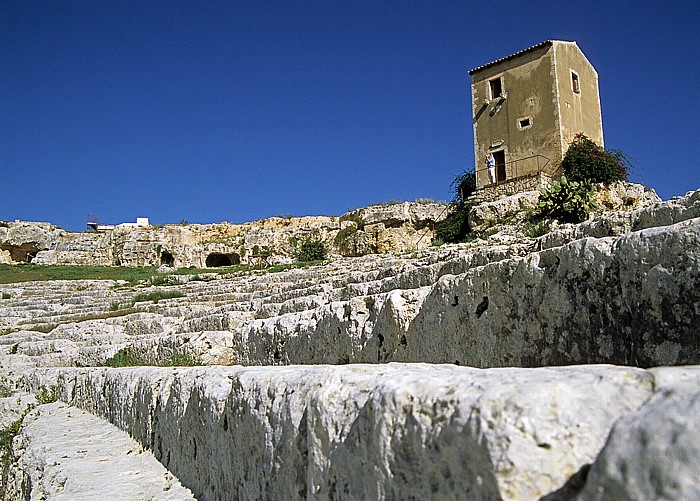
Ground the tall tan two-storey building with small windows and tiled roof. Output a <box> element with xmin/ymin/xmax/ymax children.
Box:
<box><xmin>469</xmin><ymin>40</ymin><xmax>603</xmax><ymax>200</ymax></box>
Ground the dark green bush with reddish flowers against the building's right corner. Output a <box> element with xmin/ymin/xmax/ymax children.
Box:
<box><xmin>561</xmin><ymin>132</ymin><xmax>631</xmax><ymax>183</ymax></box>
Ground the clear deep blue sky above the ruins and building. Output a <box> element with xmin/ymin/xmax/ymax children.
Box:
<box><xmin>0</xmin><ymin>0</ymin><xmax>700</xmax><ymax>231</ymax></box>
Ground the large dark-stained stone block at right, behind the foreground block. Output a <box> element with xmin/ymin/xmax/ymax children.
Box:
<box><xmin>404</xmin><ymin>219</ymin><xmax>700</xmax><ymax>367</ymax></box>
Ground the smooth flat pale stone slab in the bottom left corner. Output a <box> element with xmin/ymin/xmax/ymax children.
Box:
<box><xmin>5</xmin><ymin>403</ymin><xmax>194</xmax><ymax>501</ymax></box>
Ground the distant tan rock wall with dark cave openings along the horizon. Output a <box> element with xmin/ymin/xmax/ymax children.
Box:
<box><xmin>0</xmin><ymin>202</ymin><xmax>446</xmax><ymax>268</ymax></box>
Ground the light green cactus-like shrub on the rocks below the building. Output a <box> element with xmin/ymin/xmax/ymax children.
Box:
<box><xmin>539</xmin><ymin>176</ymin><xmax>595</xmax><ymax>223</ymax></box>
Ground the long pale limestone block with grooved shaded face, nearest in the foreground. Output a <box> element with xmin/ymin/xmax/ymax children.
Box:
<box><xmin>15</xmin><ymin>364</ymin><xmax>654</xmax><ymax>500</ymax></box>
